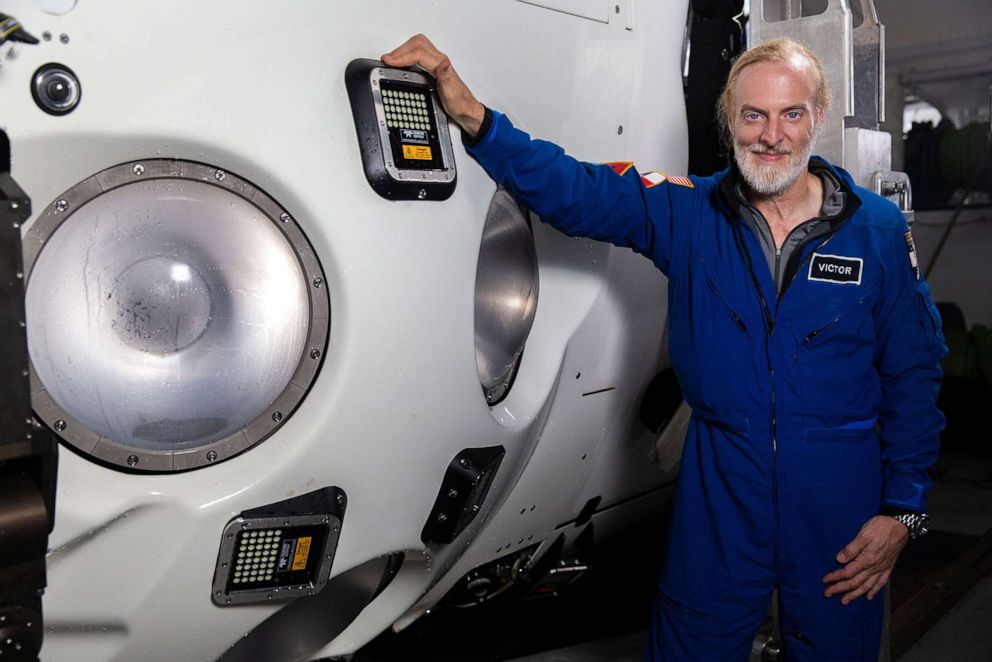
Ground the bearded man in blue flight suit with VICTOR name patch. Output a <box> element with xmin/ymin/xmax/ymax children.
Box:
<box><xmin>383</xmin><ymin>35</ymin><xmax>946</xmax><ymax>662</ymax></box>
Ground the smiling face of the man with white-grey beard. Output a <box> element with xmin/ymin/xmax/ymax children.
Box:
<box><xmin>732</xmin><ymin>61</ymin><xmax>822</xmax><ymax>195</ymax></box>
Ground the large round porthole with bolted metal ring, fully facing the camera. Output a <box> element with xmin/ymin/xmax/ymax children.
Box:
<box><xmin>25</xmin><ymin>160</ymin><xmax>330</xmax><ymax>471</ymax></box>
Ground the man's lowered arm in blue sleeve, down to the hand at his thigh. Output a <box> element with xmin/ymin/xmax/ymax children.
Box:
<box><xmin>823</xmin><ymin>218</ymin><xmax>947</xmax><ymax>604</ymax></box>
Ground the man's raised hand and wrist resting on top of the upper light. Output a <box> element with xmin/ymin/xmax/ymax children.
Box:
<box><xmin>382</xmin><ymin>34</ymin><xmax>486</xmax><ymax>138</ymax></box>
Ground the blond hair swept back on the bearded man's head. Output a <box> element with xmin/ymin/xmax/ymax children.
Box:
<box><xmin>716</xmin><ymin>37</ymin><xmax>830</xmax><ymax>144</ymax></box>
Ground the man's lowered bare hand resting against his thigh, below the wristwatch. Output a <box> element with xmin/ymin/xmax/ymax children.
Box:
<box><xmin>823</xmin><ymin>515</ymin><xmax>909</xmax><ymax>605</ymax></box>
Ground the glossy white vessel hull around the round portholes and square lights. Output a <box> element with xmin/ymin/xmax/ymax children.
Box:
<box><xmin>0</xmin><ymin>0</ymin><xmax>687</xmax><ymax>661</ymax></box>
